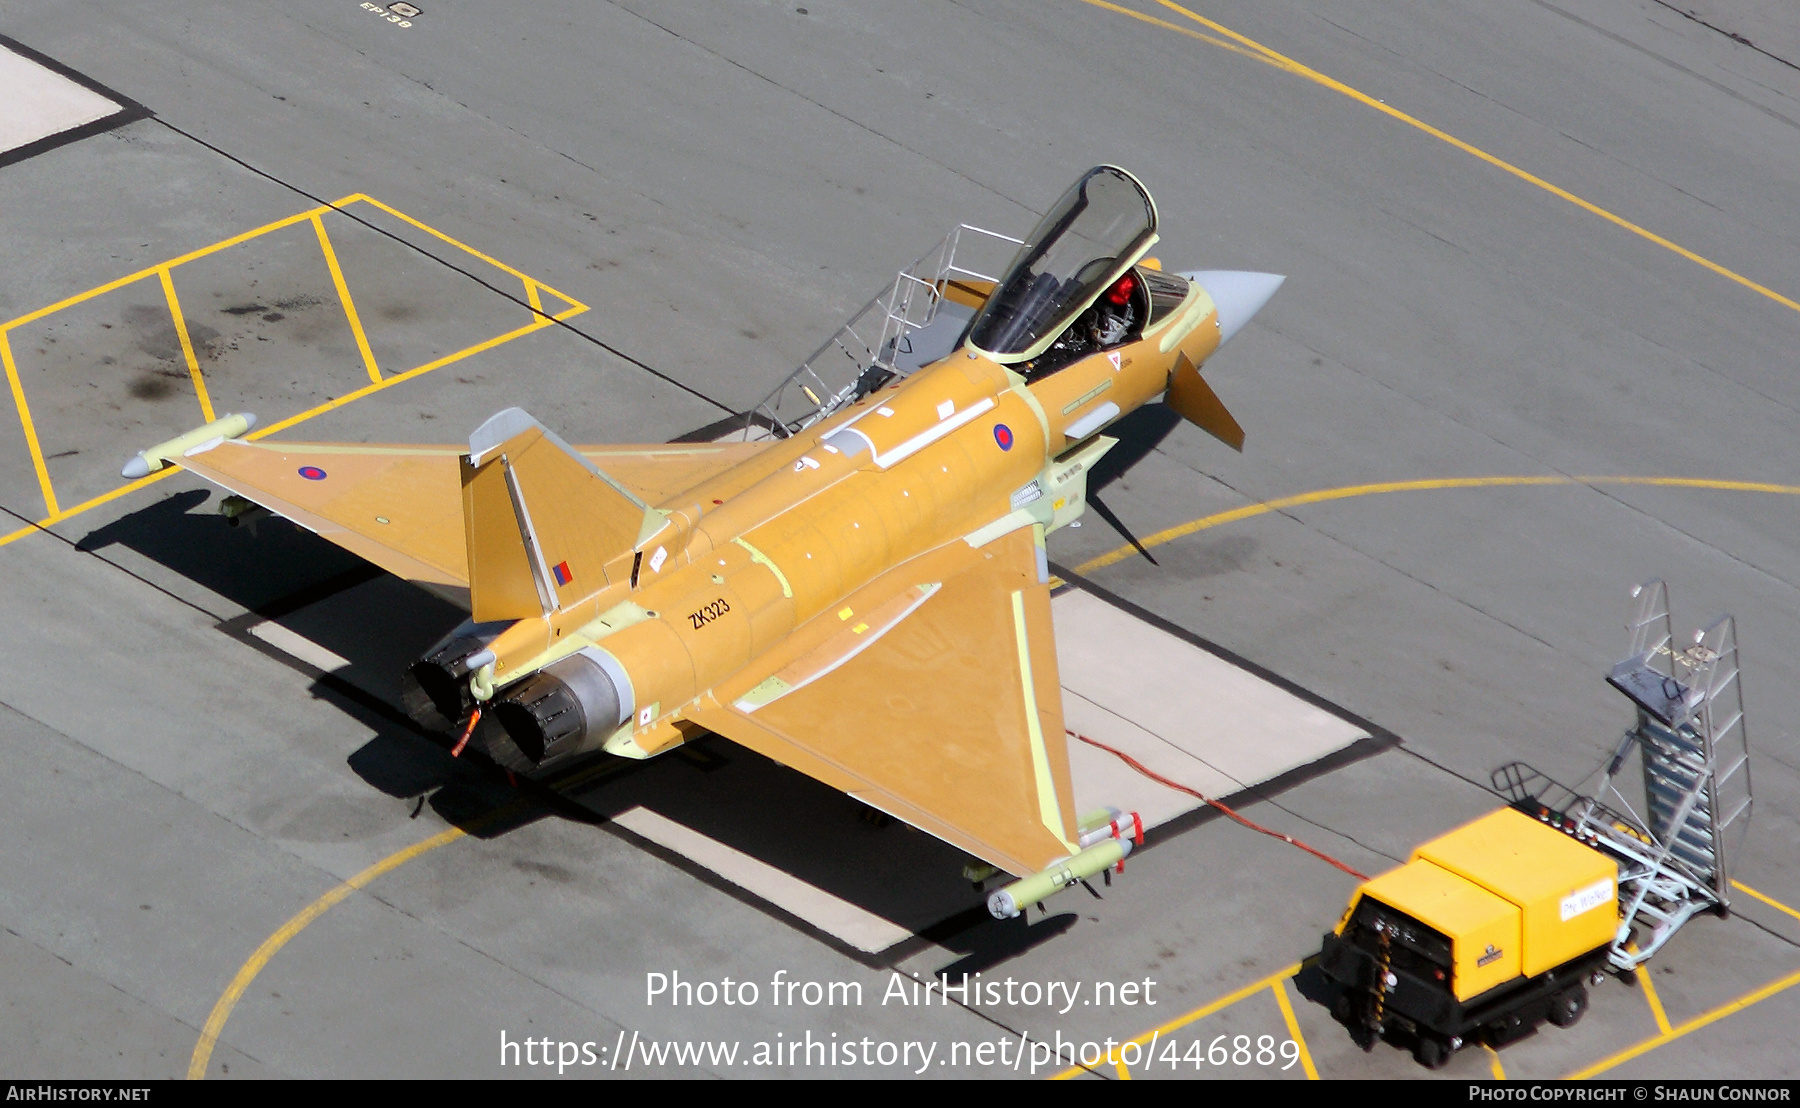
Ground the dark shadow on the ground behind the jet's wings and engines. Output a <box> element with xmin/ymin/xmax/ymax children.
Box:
<box><xmin>77</xmin><ymin>491</ymin><xmax>1078</xmax><ymax>973</ymax></box>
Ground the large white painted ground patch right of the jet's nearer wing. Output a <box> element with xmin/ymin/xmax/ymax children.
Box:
<box><xmin>1051</xmin><ymin>588</ymin><xmax>1368</xmax><ymax>826</ymax></box>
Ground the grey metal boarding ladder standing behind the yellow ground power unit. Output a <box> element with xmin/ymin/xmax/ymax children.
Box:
<box><xmin>1492</xmin><ymin>581</ymin><xmax>1751</xmax><ymax>970</ymax></box>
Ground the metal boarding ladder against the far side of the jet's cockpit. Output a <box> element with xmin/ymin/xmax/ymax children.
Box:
<box><xmin>743</xmin><ymin>223</ymin><xmax>1022</xmax><ymax>439</ymax></box>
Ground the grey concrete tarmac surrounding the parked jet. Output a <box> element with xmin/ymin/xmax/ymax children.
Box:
<box><xmin>0</xmin><ymin>0</ymin><xmax>1800</xmax><ymax>1077</ymax></box>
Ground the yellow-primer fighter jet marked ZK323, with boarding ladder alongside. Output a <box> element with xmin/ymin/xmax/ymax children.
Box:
<box><xmin>124</xmin><ymin>165</ymin><xmax>1282</xmax><ymax>916</ymax></box>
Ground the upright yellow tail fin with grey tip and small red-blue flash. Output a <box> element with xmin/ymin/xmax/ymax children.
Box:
<box><xmin>463</xmin><ymin>408</ymin><xmax>664</xmax><ymax>622</ymax></box>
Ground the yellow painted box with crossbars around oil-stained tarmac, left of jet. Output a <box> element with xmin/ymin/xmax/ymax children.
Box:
<box><xmin>0</xmin><ymin>192</ymin><xmax>587</xmax><ymax>547</ymax></box>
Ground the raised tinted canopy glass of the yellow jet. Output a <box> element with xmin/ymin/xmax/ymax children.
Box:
<box><xmin>968</xmin><ymin>165</ymin><xmax>1156</xmax><ymax>362</ymax></box>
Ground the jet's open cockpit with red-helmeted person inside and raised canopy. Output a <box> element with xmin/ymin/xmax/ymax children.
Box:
<box><xmin>965</xmin><ymin>165</ymin><xmax>1159</xmax><ymax>381</ymax></box>
